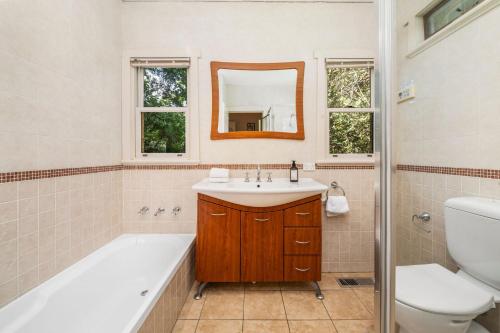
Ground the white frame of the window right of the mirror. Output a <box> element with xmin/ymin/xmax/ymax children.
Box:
<box><xmin>315</xmin><ymin>50</ymin><xmax>377</xmax><ymax>164</ymax></box>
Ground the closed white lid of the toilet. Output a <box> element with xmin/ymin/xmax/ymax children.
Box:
<box><xmin>396</xmin><ymin>264</ymin><xmax>495</xmax><ymax>315</ymax></box>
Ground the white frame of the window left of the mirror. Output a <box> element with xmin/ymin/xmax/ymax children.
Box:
<box><xmin>122</xmin><ymin>50</ymin><xmax>199</xmax><ymax>164</ymax></box>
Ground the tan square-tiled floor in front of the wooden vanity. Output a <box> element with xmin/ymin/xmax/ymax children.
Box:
<box><xmin>173</xmin><ymin>273</ymin><xmax>374</xmax><ymax>333</ymax></box>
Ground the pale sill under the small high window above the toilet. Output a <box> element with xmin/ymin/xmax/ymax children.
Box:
<box><xmin>406</xmin><ymin>0</ymin><xmax>500</xmax><ymax>59</ymax></box>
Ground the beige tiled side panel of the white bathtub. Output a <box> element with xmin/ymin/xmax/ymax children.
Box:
<box><xmin>139</xmin><ymin>247</ymin><xmax>195</xmax><ymax>333</ymax></box>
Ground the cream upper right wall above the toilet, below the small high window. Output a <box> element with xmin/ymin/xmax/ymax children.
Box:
<box><xmin>397</xmin><ymin>0</ymin><xmax>500</xmax><ymax>169</ymax></box>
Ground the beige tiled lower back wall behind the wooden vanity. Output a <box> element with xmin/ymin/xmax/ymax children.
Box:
<box><xmin>123</xmin><ymin>169</ymin><xmax>374</xmax><ymax>272</ymax></box>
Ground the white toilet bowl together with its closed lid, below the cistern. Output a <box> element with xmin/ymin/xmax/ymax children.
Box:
<box><xmin>396</xmin><ymin>264</ymin><xmax>495</xmax><ymax>333</ymax></box>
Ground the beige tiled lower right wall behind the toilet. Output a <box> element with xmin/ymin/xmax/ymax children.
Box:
<box><xmin>395</xmin><ymin>171</ymin><xmax>500</xmax><ymax>270</ymax></box>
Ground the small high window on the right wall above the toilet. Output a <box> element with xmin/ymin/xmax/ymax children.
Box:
<box><xmin>424</xmin><ymin>0</ymin><xmax>484</xmax><ymax>39</ymax></box>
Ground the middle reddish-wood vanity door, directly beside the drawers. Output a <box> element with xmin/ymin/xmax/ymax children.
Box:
<box><xmin>241</xmin><ymin>211</ymin><xmax>283</xmax><ymax>282</ymax></box>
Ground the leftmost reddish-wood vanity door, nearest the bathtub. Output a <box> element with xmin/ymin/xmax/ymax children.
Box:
<box><xmin>196</xmin><ymin>200</ymin><xmax>241</xmax><ymax>282</ymax></box>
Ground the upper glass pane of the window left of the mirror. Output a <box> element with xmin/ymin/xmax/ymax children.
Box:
<box><xmin>144</xmin><ymin>68</ymin><xmax>187</xmax><ymax>107</ymax></box>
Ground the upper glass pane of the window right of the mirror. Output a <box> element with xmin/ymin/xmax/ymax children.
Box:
<box><xmin>327</xmin><ymin>68</ymin><xmax>371</xmax><ymax>108</ymax></box>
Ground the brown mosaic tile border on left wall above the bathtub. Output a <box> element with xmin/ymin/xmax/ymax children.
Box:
<box><xmin>0</xmin><ymin>164</ymin><xmax>123</xmax><ymax>183</ymax></box>
